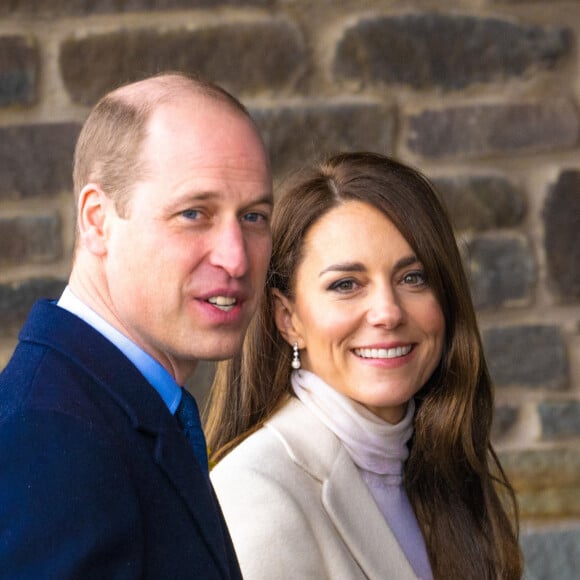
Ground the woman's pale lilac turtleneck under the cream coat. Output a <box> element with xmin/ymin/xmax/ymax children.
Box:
<box><xmin>292</xmin><ymin>369</ymin><xmax>433</xmax><ymax>580</ymax></box>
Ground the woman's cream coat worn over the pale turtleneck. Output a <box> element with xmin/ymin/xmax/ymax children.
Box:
<box><xmin>212</xmin><ymin>399</ymin><xmax>417</xmax><ymax>580</ymax></box>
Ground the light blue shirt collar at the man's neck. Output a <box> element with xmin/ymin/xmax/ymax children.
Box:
<box><xmin>57</xmin><ymin>286</ymin><xmax>181</xmax><ymax>415</ymax></box>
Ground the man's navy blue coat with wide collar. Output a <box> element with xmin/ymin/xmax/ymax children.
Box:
<box><xmin>0</xmin><ymin>301</ymin><xmax>241</xmax><ymax>580</ymax></box>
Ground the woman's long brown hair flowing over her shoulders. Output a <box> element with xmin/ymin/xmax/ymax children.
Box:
<box><xmin>207</xmin><ymin>153</ymin><xmax>522</xmax><ymax>580</ymax></box>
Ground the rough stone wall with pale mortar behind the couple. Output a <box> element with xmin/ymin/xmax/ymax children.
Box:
<box><xmin>0</xmin><ymin>0</ymin><xmax>580</xmax><ymax>579</ymax></box>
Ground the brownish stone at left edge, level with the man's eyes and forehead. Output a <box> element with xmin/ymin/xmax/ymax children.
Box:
<box><xmin>0</xmin><ymin>123</ymin><xmax>80</xmax><ymax>201</ymax></box>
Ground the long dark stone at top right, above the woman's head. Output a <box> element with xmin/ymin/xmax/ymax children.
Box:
<box><xmin>334</xmin><ymin>13</ymin><xmax>572</xmax><ymax>89</ymax></box>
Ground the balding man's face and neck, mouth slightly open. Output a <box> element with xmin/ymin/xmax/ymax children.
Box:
<box><xmin>105</xmin><ymin>97</ymin><xmax>272</xmax><ymax>383</ymax></box>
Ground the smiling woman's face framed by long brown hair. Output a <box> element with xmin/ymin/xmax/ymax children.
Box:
<box><xmin>276</xmin><ymin>201</ymin><xmax>445</xmax><ymax>423</ymax></box>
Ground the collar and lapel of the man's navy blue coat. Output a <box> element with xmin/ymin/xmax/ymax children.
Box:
<box><xmin>19</xmin><ymin>300</ymin><xmax>229</xmax><ymax>578</ymax></box>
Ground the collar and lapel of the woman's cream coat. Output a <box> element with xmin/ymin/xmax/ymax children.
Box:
<box><xmin>266</xmin><ymin>398</ymin><xmax>417</xmax><ymax>580</ymax></box>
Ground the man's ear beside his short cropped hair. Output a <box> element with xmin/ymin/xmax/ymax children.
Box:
<box><xmin>77</xmin><ymin>183</ymin><xmax>113</xmax><ymax>256</ymax></box>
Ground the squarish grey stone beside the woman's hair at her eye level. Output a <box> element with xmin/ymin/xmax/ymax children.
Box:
<box><xmin>467</xmin><ymin>235</ymin><xmax>536</xmax><ymax>309</ymax></box>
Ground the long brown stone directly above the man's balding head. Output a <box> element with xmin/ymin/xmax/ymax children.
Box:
<box><xmin>60</xmin><ymin>20</ymin><xmax>308</xmax><ymax>105</ymax></box>
